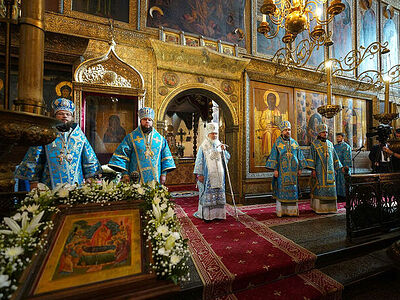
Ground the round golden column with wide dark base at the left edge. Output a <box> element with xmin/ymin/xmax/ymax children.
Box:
<box><xmin>0</xmin><ymin>0</ymin><xmax>58</xmax><ymax>197</ymax></box>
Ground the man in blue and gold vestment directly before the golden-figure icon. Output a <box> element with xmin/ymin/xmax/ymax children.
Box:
<box><xmin>266</xmin><ymin>121</ymin><xmax>307</xmax><ymax>217</ymax></box>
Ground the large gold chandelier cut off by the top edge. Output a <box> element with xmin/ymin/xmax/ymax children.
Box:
<box><xmin>257</xmin><ymin>0</ymin><xmax>345</xmax><ymax>67</ymax></box>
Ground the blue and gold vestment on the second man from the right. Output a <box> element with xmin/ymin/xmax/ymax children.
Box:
<box><xmin>307</xmin><ymin>139</ymin><xmax>342</xmax><ymax>205</ymax></box>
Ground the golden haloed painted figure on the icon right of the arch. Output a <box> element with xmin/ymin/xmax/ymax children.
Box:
<box><xmin>259</xmin><ymin>90</ymin><xmax>288</xmax><ymax>156</ymax></box>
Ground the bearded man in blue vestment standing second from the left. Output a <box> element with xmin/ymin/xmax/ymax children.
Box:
<box><xmin>108</xmin><ymin>107</ymin><xmax>176</xmax><ymax>184</ymax></box>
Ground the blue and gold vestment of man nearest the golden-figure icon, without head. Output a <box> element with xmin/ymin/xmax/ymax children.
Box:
<box><xmin>266</xmin><ymin>136</ymin><xmax>307</xmax><ymax>202</ymax></box>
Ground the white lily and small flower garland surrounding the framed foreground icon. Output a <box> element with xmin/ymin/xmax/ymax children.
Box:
<box><xmin>0</xmin><ymin>181</ymin><xmax>189</xmax><ymax>299</ymax></box>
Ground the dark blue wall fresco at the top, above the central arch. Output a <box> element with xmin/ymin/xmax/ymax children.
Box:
<box><xmin>147</xmin><ymin>0</ymin><xmax>246</xmax><ymax>46</ymax></box>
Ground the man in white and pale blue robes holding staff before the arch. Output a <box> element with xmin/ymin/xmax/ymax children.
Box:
<box><xmin>193</xmin><ymin>123</ymin><xmax>230</xmax><ymax>221</ymax></box>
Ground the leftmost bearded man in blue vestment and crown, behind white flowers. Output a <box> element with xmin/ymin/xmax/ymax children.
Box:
<box><xmin>15</xmin><ymin>98</ymin><xmax>101</xmax><ymax>189</ymax></box>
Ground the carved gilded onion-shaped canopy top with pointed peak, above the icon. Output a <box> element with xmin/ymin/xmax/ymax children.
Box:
<box><xmin>74</xmin><ymin>42</ymin><xmax>145</xmax><ymax>98</ymax></box>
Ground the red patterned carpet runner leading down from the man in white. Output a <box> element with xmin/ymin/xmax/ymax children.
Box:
<box><xmin>175</xmin><ymin>197</ymin><xmax>341</xmax><ymax>300</ymax></box>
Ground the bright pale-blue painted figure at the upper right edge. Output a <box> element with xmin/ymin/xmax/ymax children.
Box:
<box><xmin>382</xmin><ymin>5</ymin><xmax>399</xmax><ymax>72</ymax></box>
